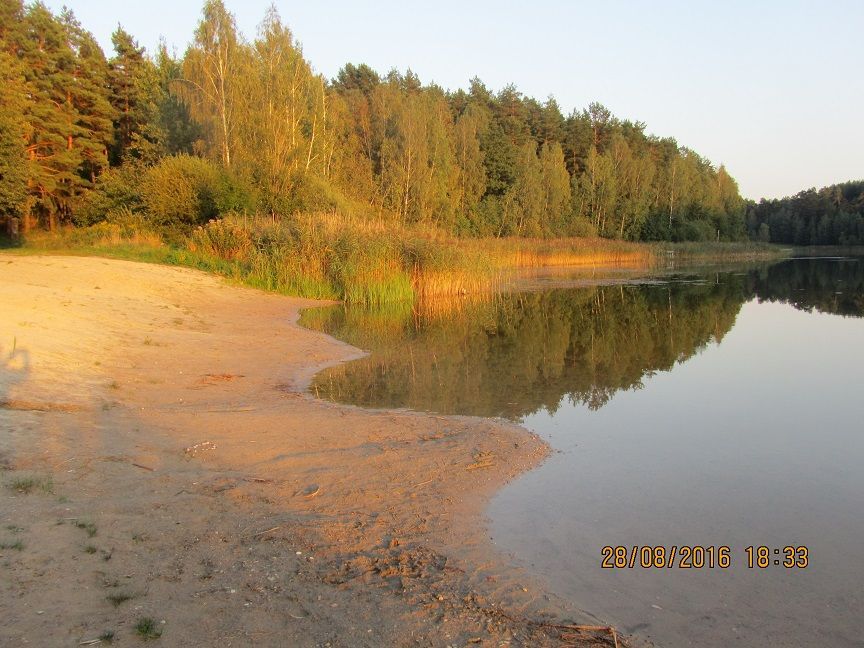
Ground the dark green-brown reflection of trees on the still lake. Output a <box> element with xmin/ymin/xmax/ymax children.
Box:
<box><xmin>304</xmin><ymin>261</ymin><xmax>864</xmax><ymax>419</ymax></box>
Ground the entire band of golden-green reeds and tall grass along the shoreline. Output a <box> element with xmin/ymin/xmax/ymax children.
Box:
<box><xmin>8</xmin><ymin>212</ymin><xmax>788</xmax><ymax>306</ymax></box>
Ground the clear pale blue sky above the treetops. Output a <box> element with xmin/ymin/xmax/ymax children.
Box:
<box><xmin>47</xmin><ymin>0</ymin><xmax>864</xmax><ymax>199</ymax></box>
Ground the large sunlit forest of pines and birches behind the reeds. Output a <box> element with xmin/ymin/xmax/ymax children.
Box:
<box><xmin>0</xmin><ymin>0</ymin><xmax>746</xmax><ymax>240</ymax></box>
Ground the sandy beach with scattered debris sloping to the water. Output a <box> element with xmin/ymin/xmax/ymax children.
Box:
<box><xmin>0</xmin><ymin>255</ymin><xmax>620</xmax><ymax>646</ymax></box>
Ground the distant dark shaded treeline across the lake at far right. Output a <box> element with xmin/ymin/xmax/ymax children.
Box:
<box><xmin>747</xmin><ymin>180</ymin><xmax>864</xmax><ymax>245</ymax></box>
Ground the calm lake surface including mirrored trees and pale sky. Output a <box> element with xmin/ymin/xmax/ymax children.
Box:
<box><xmin>304</xmin><ymin>259</ymin><xmax>864</xmax><ymax>647</ymax></box>
